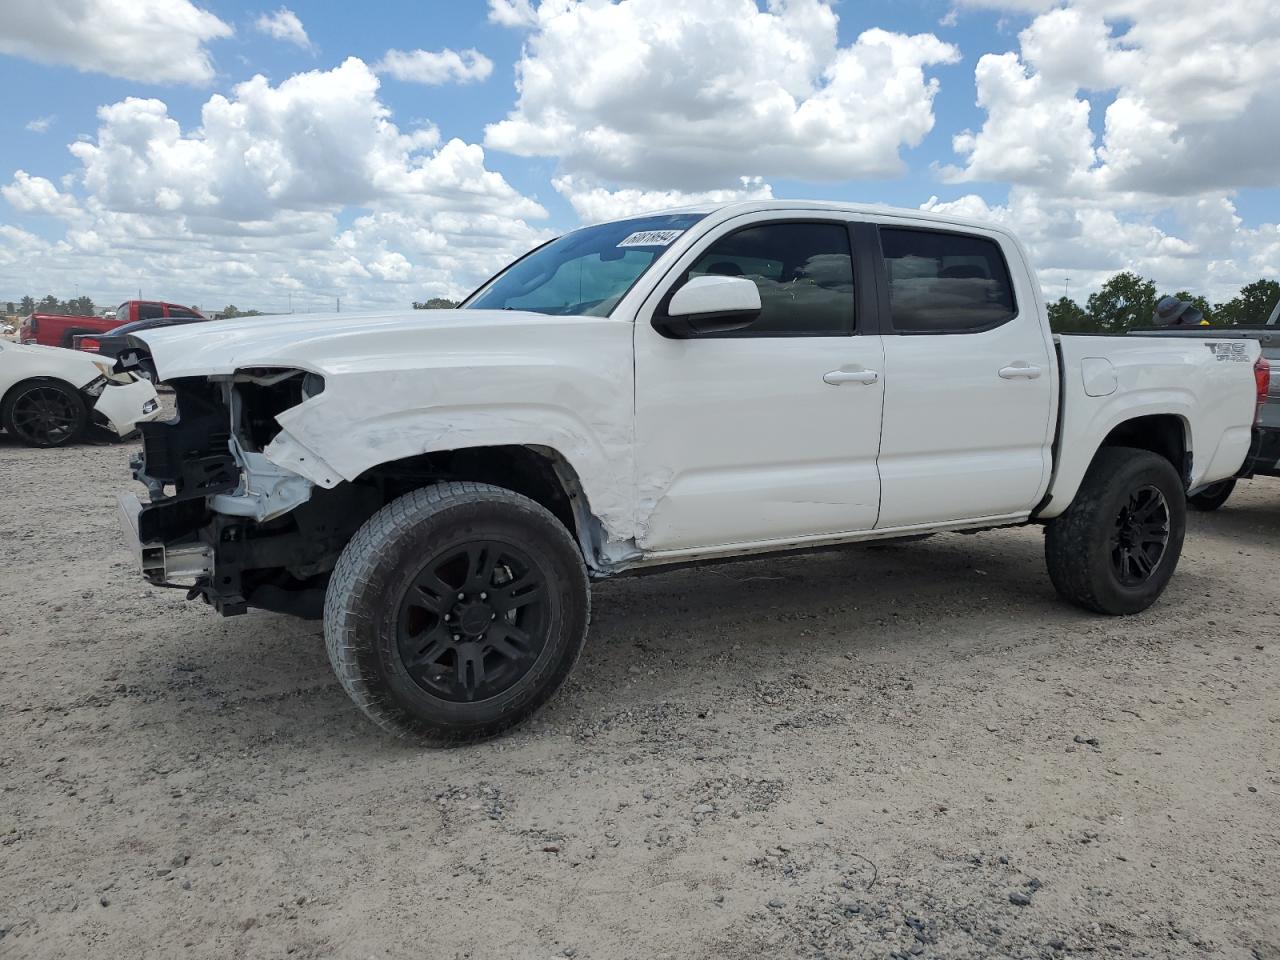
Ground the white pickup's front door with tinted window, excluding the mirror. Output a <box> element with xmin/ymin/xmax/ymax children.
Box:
<box><xmin>635</xmin><ymin>214</ymin><xmax>884</xmax><ymax>553</ymax></box>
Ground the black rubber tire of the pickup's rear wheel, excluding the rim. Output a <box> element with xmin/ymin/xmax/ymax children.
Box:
<box><xmin>1044</xmin><ymin>447</ymin><xmax>1187</xmax><ymax>616</ymax></box>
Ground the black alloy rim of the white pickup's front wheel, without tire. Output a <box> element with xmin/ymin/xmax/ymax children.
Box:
<box><xmin>396</xmin><ymin>540</ymin><xmax>548</xmax><ymax>703</ymax></box>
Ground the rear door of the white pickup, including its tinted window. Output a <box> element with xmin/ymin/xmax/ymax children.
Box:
<box><xmin>877</xmin><ymin>221</ymin><xmax>1056</xmax><ymax>529</ymax></box>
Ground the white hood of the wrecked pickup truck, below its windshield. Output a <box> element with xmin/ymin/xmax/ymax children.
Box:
<box><xmin>129</xmin><ymin>310</ymin><xmax>621</xmax><ymax>380</ymax></box>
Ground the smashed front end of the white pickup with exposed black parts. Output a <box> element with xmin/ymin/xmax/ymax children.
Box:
<box><xmin>120</xmin><ymin>369</ymin><xmax>379</xmax><ymax>618</ymax></box>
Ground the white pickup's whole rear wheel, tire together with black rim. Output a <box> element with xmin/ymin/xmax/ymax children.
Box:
<box><xmin>1044</xmin><ymin>447</ymin><xmax>1187</xmax><ymax>614</ymax></box>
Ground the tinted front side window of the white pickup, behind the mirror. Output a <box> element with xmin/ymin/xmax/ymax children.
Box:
<box><xmin>676</xmin><ymin>223</ymin><xmax>854</xmax><ymax>337</ymax></box>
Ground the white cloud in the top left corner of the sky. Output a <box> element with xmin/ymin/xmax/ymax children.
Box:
<box><xmin>0</xmin><ymin>0</ymin><xmax>233</xmax><ymax>84</ymax></box>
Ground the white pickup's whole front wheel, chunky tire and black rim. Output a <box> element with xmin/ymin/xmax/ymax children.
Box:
<box><xmin>324</xmin><ymin>483</ymin><xmax>590</xmax><ymax>745</ymax></box>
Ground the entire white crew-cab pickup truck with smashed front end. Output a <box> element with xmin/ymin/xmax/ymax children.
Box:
<box><xmin>122</xmin><ymin>201</ymin><xmax>1258</xmax><ymax>742</ymax></box>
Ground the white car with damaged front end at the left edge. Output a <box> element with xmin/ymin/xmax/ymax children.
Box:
<box><xmin>0</xmin><ymin>340</ymin><xmax>161</xmax><ymax>447</ymax></box>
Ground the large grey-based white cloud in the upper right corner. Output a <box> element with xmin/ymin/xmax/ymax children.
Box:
<box><xmin>943</xmin><ymin>0</ymin><xmax>1280</xmax><ymax>196</ymax></box>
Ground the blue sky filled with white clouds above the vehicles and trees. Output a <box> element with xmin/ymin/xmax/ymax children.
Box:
<box><xmin>0</xmin><ymin>0</ymin><xmax>1280</xmax><ymax>310</ymax></box>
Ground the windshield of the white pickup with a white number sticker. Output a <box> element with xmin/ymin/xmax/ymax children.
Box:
<box><xmin>462</xmin><ymin>214</ymin><xmax>705</xmax><ymax>316</ymax></box>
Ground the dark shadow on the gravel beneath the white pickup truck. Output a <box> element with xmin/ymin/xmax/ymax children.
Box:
<box><xmin>136</xmin><ymin>532</ymin><xmax>1070</xmax><ymax>751</ymax></box>
